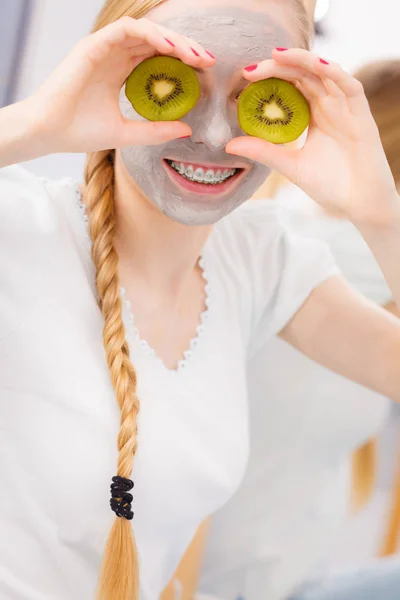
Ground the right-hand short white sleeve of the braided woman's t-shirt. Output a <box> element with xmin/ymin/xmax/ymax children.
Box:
<box><xmin>230</xmin><ymin>200</ymin><xmax>340</xmax><ymax>356</ymax></box>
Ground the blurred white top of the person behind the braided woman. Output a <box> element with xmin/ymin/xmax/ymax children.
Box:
<box><xmin>200</xmin><ymin>186</ymin><xmax>391</xmax><ymax>600</ymax></box>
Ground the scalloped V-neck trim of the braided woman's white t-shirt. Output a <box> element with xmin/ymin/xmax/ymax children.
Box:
<box><xmin>70</xmin><ymin>180</ymin><xmax>211</xmax><ymax>374</ymax></box>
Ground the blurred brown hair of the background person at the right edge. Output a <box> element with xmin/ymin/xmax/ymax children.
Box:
<box><xmin>354</xmin><ymin>59</ymin><xmax>400</xmax><ymax>184</ymax></box>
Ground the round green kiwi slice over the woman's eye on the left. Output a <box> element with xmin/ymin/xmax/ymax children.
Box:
<box><xmin>125</xmin><ymin>56</ymin><xmax>200</xmax><ymax>121</ymax></box>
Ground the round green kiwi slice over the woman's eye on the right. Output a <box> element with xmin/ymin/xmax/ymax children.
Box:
<box><xmin>238</xmin><ymin>77</ymin><xmax>310</xmax><ymax>144</ymax></box>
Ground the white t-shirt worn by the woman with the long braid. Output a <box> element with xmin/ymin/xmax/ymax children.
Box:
<box><xmin>0</xmin><ymin>166</ymin><xmax>337</xmax><ymax>600</ymax></box>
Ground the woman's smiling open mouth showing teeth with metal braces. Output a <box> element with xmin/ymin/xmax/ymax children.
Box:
<box><xmin>163</xmin><ymin>159</ymin><xmax>246</xmax><ymax>194</ymax></box>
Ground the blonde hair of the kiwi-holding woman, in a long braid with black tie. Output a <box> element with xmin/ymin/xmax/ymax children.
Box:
<box><xmin>85</xmin><ymin>0</ymin><xmax>310</xmax><ymax>600</ymax></box>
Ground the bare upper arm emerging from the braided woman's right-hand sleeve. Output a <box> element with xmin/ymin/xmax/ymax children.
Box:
<box><xmin>280</xmin><ymin>277</ymin><xmax>400</xmax><ymax>402</ymax></box>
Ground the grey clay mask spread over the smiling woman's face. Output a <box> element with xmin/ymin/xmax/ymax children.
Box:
<box><xmin>120</xmin><ymin>8</ymin><xmax>290</xmax><ymax>225</ymax></box>
